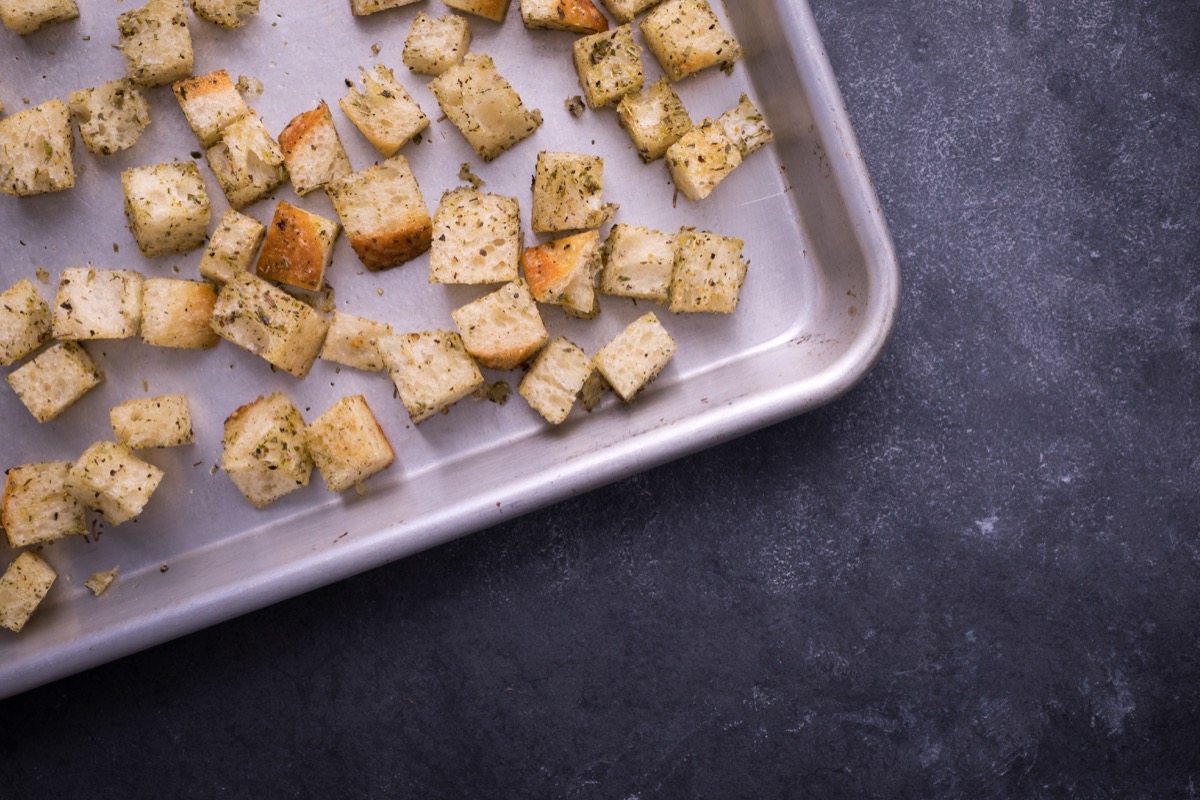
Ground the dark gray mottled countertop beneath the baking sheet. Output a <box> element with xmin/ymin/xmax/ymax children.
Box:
<box><xmin>0</xmin><ymin>0</ymin><xmax>1200</xmax><ymax>800</ymax></box>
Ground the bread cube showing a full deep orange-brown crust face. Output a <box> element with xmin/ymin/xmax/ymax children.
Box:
<box><xmin>256</xmin><ymin>200</ymin><xmax>342</xmax><ymax>291</ymax></box>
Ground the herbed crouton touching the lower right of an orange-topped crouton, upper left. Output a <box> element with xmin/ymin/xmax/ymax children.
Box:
<box><xmin>204</xmin><ymin>114</ymin><xmax>288</xmax><ymax>211</ymax></box>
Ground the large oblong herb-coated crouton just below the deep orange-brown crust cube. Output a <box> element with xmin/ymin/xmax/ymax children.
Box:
<box><xmin>212</xmin><ymin>272</ymin><xmax>329</xmax><ymax>378</ymax></box>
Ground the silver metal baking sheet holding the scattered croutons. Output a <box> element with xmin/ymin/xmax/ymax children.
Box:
<box><xmin>0</xmin><ymin>0</ymin><xmax>899</xmax><ymax>696</ymax></box>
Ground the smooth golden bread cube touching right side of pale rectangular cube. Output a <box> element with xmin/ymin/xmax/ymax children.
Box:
<box><xmin>142</xmin><ymin>278</ymin><xmax>218</xmax><ymax>350</ymax></box>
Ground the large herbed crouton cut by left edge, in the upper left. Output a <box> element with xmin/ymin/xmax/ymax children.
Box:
<box><xmin>0</xmin><ymin>98</ymin><xmax>74</xmax><ymax>197</ymax></box>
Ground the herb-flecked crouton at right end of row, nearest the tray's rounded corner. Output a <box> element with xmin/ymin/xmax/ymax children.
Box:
<box><xmin>671</xmin><ymin>228</ymin><xmax>748</xmax><ymax>314</ymax></box>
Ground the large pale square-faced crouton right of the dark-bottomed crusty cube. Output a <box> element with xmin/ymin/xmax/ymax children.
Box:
<box><xmin>430</xmin><ymin>188</ymin><xmax>521</xmax><ymax>283</ymax></box>
